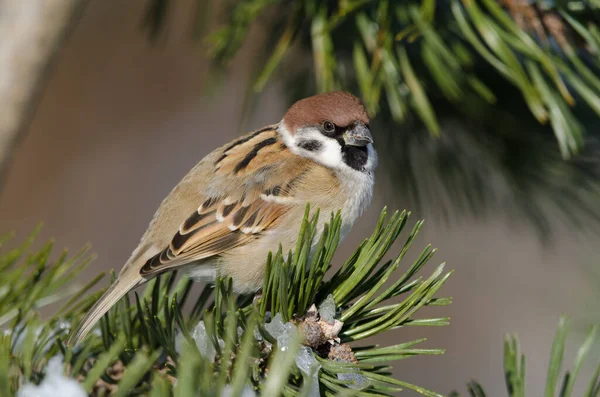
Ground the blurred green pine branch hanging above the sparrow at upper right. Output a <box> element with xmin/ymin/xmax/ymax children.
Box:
<box><xmin>144</xmin><ymin>0</ymin><xmax>600</xmax><ymax>158</ymax></box>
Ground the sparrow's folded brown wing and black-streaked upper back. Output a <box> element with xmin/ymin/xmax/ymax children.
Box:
<box><xmin>140</xmin><ymin>125</ymin><xmax>307</xmax><ymax>278</ymax></box>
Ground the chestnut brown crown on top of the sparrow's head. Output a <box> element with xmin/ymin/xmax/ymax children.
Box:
<box><xmin>283</xmin><ymin>91</ymin><xmax>369</xmax><ymax>133</ymax></box>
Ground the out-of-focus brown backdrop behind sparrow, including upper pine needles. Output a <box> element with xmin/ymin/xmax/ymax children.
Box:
<box><xmin>0</xmin><ymin>0</ymin><xmax>600</xmax><ymax>396</ymax></box>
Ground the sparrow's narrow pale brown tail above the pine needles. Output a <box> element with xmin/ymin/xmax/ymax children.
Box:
<box><xmin>67</xmin><ymin>272</ymin><xmax>146</xmax><ymax>346</ymax></box>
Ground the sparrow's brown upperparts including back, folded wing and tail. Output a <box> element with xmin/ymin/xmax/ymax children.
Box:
<box><xmin>68</xmin><ymin>125</ymin><xmax>308</xmax><ymax>346</ymax></box>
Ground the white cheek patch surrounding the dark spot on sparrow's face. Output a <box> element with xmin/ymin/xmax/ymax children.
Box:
<box><xmin>279</xmin><ymin>122</ymin><xmax>345</xmax><ymax>168</ymax></box>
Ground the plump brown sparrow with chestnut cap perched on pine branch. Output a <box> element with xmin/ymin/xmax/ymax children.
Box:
<box><xmin>67</xmin><ymin>92</ymin><xmax>377</xmax><ymax>346</ymax></box>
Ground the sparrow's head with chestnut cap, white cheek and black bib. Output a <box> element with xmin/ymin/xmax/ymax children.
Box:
<box><xmin>279</xmin><ymin>91</ymin><xmax>377</xmax><ymax>172</ymax></box>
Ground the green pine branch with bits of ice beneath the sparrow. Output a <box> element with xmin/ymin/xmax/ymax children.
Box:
<box><xmin>0</xmin><ymin>208</ymin><xmax>451</xmax><ymax>396</ymax></box>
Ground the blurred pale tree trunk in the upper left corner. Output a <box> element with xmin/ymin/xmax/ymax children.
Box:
<box><xmin>0</xmin><ymin>0</ymin><xmax>88</xmax><ymax>189</ymax></box>
